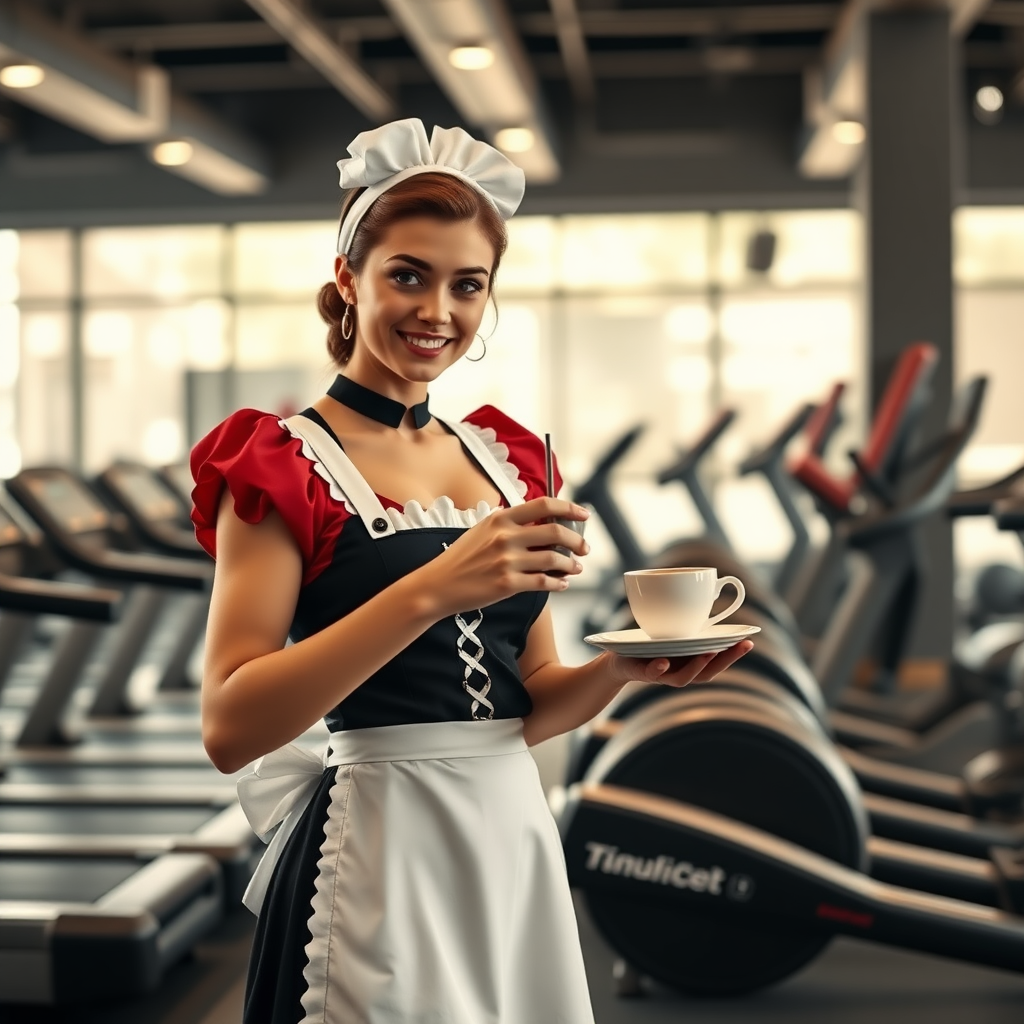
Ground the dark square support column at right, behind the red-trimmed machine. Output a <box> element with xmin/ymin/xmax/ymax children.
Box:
<box><xmin>856</xmin><ymin>8</ymin><xmax>958</xmax><ymax>658</ymax></box>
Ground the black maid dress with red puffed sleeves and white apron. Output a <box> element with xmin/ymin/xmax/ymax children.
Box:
<box><xmin>191</xmin><ymin>407</ymin><xmax>593</xmax><ymax>1024</ymax></box>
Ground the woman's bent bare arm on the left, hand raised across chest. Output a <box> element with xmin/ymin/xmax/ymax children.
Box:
<box><xmin>203</xmin><ymin>493</ymin><xmax>586</xmax><ymax>772</ymax></box>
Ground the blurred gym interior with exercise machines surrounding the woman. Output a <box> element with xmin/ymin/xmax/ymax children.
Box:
<box><xmin>0</xmin><ymin>0</ymin><xmax>1024</xmax><ymax>1024</ymax></box>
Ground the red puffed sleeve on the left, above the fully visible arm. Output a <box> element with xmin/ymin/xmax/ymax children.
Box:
<box><xmin>190</xmin><ymin>409</ymin><xmax>350</xmax><ymax>586</ymax></box>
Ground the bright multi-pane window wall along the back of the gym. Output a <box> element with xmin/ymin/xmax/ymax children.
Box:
<box><xmin>8</xmin><ymin>209</ymin><xmax>1024</xmax><ymax>577</ymax></box>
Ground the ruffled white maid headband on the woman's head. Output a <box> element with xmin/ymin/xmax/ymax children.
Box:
<box><xmin>338</xmin><ymin>118</ymin><xmax>526</xmax><ymax>255</ymax></box>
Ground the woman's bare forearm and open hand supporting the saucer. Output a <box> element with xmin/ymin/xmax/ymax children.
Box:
<box><xmin>519</xmin><ymin>605</ymin><xmax>754</xmax><ymax>745</ymax></box>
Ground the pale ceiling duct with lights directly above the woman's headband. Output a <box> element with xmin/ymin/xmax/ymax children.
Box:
<box><xmin>383</xmin><ymin>0</ymin><xmax>560</xmax><ymax>183</ymax></box>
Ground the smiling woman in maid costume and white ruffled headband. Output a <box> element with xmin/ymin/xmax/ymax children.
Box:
<box><xmin>193</xmin><ymin>120</ymin><xmax>750</xmax><ymax>1024</ymax></box>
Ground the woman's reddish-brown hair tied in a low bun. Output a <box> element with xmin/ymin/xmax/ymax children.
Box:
<box><xmin>316</xmin><ymin>171</ymin><xmax>508</xmax><ymax>367</ymax></box>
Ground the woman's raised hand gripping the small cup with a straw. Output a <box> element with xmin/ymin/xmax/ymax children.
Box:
<box><xmin>417</xmin><ymin>498</ymin><xmax>590</xmax><ymax>616</ymax></box>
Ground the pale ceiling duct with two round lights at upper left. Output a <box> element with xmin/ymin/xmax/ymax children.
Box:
<box><xmin>0</xmin><ymin>3</ymin><xmax>268</xmax><ymax>196</ymax></box>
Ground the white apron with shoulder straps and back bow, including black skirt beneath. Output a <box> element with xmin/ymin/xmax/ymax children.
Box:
<box><xmin>239</xmin><ymin>417</ymin><xmax>593</xmax><ymax>1024</ymax></box>
